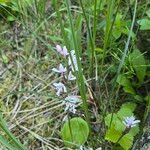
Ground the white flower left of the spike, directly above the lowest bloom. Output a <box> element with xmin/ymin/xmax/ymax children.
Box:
<box><xmin>53</xmin><ymin>82</ymin><xmax>67</xmax><ymax>96</ymax></box>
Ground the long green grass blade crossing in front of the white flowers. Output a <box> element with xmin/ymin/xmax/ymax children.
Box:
<box><xmin>65</xmin><ymin>0</ymin><xmax>90</xmax><ymax>125</ymax></box>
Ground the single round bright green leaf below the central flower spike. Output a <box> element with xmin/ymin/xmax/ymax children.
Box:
<box><xmin>61</xmin><ymin>117</ymin><xmax>89</xmax><ymax>148</ymax></box>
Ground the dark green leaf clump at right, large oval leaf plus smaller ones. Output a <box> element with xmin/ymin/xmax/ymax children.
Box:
<box><xmin>117</xmin><ymin>49</ymin><xmax>147</xmax><ymax>98</ymax></box>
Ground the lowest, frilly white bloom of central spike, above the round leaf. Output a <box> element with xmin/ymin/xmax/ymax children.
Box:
<box><xmin>63</xmin><ymin>95</ymin><xmax>80</xmax><ymax>114</ymax></box>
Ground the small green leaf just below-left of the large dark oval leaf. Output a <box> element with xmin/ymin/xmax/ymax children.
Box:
<box><xmin>117</xmin><ymin>74</ymin><xmax>135</xmax><ymax>95</ymax></box>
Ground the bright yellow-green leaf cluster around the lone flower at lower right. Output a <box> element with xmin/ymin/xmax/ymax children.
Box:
<box><xmin>105</xmin><ymin>103</ymin><xmax>139</xmax><ymax>150</ymax></box>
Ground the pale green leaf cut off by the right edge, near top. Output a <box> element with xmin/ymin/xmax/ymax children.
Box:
<box><xmin>138</xmin><ymin>18</ymin><xmax>150</xmax><ymax>30</ymax></box>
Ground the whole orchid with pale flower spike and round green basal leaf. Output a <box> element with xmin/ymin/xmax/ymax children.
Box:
<box><xmin>52</xmin><ymin>45</ymin><xmax>89</xmax><ymax>149</ymax></box>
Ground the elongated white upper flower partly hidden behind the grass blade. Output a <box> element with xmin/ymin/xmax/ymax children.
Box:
<box><xmin>68</xmin><ymin>50</ymin><xmax>78</xmax><ymax>72</ymax></box>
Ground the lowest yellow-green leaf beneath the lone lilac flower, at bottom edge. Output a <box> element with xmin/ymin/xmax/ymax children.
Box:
<box><xmin>119</xmin><ymin>134</ymin><xmax>133</xmax><ymax>150</ymax></box>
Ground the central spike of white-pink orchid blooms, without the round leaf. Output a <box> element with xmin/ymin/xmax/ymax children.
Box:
<box><xmin>52</xmin><ymin>45</ymin><xmax>80</xmax><ymax>114</ymax></box>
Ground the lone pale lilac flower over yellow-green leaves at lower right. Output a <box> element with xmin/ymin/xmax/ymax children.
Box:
<box><xmin>123</xmin><ymin>116</ymin><xmax>140</xmax><ymax>128</ymax></box>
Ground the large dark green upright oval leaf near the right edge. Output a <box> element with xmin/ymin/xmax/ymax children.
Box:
<box><xmin>129</xmin><ymin>49</ymin><xmax>146</xmax><ymax>83</ymax></box>
